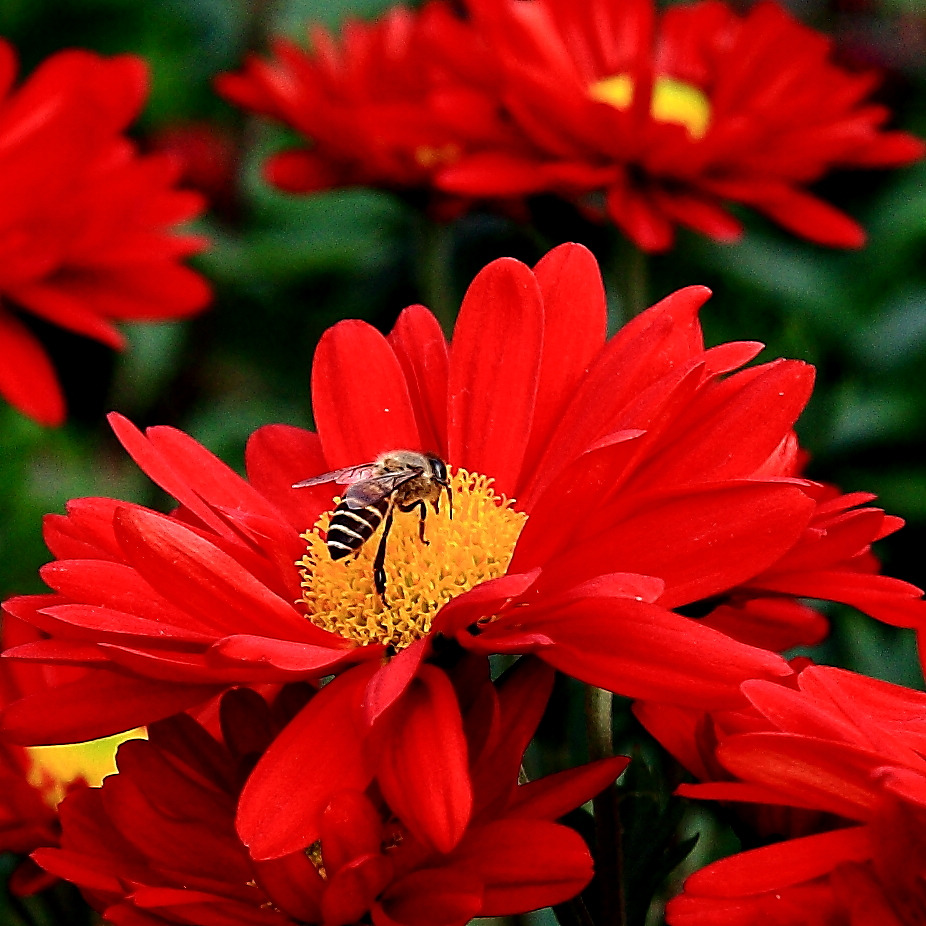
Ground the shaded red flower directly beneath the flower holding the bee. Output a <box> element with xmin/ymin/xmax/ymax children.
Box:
<box><xmin>36</xmin><ymin>665</ymin><xmax>627</xmax><ymax>926</ymax></box>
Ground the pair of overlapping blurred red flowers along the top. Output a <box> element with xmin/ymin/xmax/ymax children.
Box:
<box><xmin>218</xmin><ymin>0</ymin><xmax>924</xmax><ymax>251</ymax></box>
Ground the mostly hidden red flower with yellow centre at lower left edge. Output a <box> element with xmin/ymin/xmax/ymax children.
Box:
<box><xmin>0</xmin><ymin>616</ymin><xmax>142</xmax><ymax>895</ymax></box>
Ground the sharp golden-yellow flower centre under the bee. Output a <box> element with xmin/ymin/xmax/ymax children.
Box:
<box><xmin>297</xmin><ymin>469</ymin><xmax>527</xmax><ymax>649</ymax></box>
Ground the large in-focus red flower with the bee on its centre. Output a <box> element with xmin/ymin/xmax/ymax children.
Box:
<box><xmin>3</xmin><ymin>245</ymin><xmax>926</xmax><ymax>742</ymax></box>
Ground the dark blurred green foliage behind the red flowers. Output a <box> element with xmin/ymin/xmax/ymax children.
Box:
<box><xmin>0</xmin><ymin>0</ymin><xmax>926</xmax><ymax>923</ymax></box>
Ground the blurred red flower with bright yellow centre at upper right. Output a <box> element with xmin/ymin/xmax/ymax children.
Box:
<box><xmin>436</xmin><ymin>0</ymin><xmax>924</xmax><ymax>251</ymax></box>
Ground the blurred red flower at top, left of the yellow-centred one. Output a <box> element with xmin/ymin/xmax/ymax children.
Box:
<box><xmin>216</xmin><ymin>2</ymin><xmax>486</xmax><ymax>218</ymax></box>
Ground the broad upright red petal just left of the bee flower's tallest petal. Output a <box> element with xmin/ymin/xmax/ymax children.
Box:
<box><xmin>447</xmin><ymin>258</ymin><xmax>544</xmax><ymax>496</ymax></box>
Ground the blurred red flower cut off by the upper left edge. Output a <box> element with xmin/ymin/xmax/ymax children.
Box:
<box><xmin>0</xmin><ymin>40</ymin><xmax>210</xmax><ymax>425</ymax></box>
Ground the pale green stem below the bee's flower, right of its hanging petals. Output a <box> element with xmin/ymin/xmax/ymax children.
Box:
<box><xmin>585</xmin><ymin>685</ymin><xmax>627</xmax><ymax>926</ymax></box>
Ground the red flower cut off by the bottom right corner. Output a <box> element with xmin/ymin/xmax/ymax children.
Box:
<box><xmin>650</xmin><ymin>666</ymin><xmax>926</xmax><ymax>926</ymax></box>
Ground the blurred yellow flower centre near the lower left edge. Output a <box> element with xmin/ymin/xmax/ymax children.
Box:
<box><xmin>26</xmin><ymin>727</ymin><xmax>148</xmax><ymax>807</ymax></box>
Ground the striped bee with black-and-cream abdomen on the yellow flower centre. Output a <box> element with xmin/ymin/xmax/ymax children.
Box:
<box><xmin>293</xmin><ymin>450</ymin><xmax>453</xmax><ymax>604</ymax></box>
